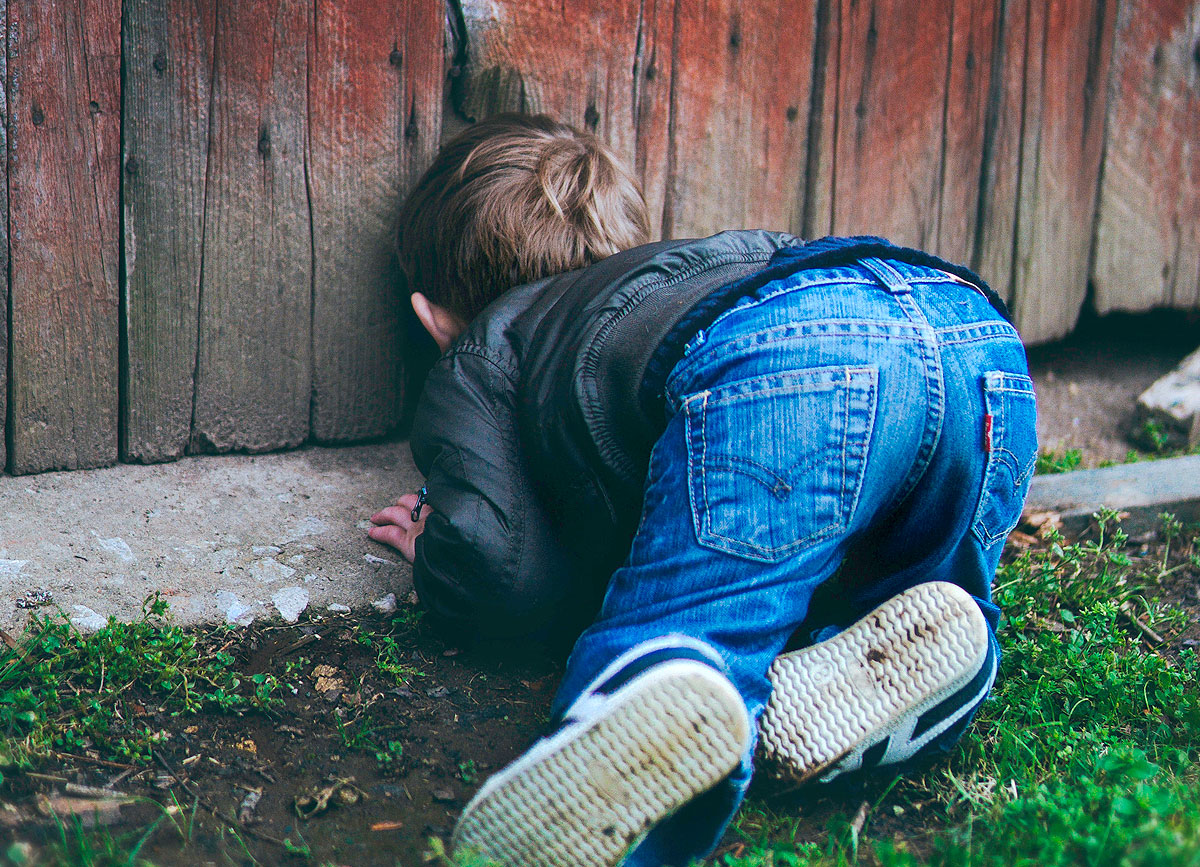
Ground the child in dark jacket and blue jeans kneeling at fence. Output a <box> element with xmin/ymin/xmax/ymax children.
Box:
<box><xmin>370</xmin><ymin>115</ymin><xmax>1036</xmax><ymax>866</ymax></box>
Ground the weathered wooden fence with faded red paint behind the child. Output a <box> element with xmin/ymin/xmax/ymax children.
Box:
<box><xmin>0</xmin><ymin>0</ymin><xmax>1200</xmax><ymax>473</ymax></box>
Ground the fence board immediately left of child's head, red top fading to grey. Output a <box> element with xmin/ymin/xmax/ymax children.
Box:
<box><xmin>308</xmin><ymin>0</ymin><xmax>444</xmax><ymax>441</ymax></box>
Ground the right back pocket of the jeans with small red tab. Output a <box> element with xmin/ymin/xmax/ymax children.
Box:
<box><xmin>971</xmin><ymin>370</ymin><xmax>1038</xmax><ymax>548</ymax></box>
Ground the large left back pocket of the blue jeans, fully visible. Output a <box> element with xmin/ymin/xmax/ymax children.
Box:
<box><xmin>684</xmin><ymin>367</ymin><xmax>878</xmax><ymax>562</ymax></box>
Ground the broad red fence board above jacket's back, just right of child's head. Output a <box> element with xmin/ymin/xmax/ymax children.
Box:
<box><xmin>662</xmin><ymin>0</ymin><xmax>816</xmax><ymax>237</ymax></box>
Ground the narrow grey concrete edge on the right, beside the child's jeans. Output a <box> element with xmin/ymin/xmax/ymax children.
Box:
<box><xmin>1025</xmin><ymin>455</ymin><xmax>1200</xmax><ymax>536</ymax></box>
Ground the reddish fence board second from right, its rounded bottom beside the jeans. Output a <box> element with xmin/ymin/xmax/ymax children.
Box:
<box><xmin>989</xmin><ymin>0</ymin><xmax>1115</xmax><ymax>343</ymax></box>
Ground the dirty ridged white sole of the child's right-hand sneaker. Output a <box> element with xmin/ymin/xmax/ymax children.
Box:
<box><xmin>760</xmin><ymin>581</ymin><xmax>990</xmax><ymax>783</ymax></box>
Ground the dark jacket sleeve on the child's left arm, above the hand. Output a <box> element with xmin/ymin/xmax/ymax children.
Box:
<box><xmin>412</xmin><ymin>343</ymin><xmax>570</xmax><ymax>636</ymax></box>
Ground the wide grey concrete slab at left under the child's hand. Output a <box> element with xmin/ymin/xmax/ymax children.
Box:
<box><xmin>0</xmin><ymin>443</ymin><xmax>420</xmax><ymax>630</ymax></box>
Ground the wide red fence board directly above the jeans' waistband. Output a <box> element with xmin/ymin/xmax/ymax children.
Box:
<box><xmin>812</xmin><ymin>0</ymin><xmax>953</xmax><ymax>247</ymax></box>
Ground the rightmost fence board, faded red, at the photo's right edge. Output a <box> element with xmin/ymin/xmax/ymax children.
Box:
<box><xmin>1092</xmin><ymin>0</ymin><xmax>1200</xmax><ymax>312</ymax></box>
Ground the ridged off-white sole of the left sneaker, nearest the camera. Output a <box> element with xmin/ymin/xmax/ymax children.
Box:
<box><xmin>451</xmin><ymin>660</ymin><xmax>750</xmax><ymax>867</ymax></box>
